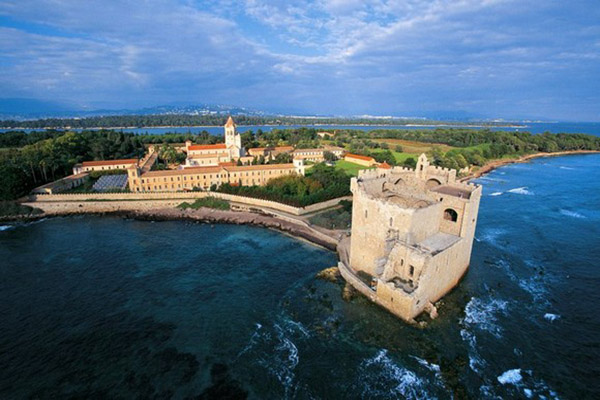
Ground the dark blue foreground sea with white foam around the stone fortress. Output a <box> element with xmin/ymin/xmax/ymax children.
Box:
<box><xmin>0</xmin><ymin>155</ymin><xmax>600</xmax><ymax>399</ymax></box>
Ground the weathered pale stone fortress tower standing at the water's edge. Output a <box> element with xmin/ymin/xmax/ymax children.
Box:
<box><xmin>346</xmin><ymin>154</ymin><xmax>482</xmax><ymax>321</ymax></box>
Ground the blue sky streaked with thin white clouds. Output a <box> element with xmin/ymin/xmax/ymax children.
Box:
<box><xmin>0</xmin><ymin>0</ymin><xmax>600</xmax><ymax>121</ymax></box>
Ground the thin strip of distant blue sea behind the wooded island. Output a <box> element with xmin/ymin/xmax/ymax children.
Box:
<box><xmin>0</xmin><ymin>122</ymin><xmax>600</xmax><ymax>136</ymax></box>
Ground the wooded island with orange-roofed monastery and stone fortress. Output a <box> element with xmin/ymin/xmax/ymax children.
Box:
<box><xmin>3</xmin><ymin>116</ymin><xmax>600</xmax><ymax>323</ymax></box>
